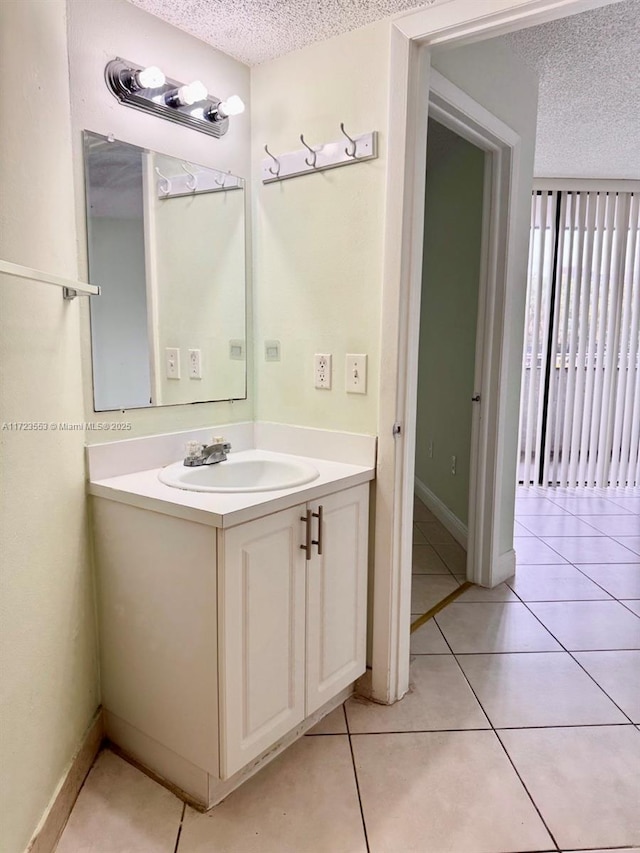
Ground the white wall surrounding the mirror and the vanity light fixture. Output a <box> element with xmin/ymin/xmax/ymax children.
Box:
<box><xmin>68</xmin><ymin>0</ymin><xmax>253</xmax><ymax>442</ymax></box>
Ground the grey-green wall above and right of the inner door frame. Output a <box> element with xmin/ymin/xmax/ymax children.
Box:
<box><xmin>432</xmin><ymin>39</ymin><xmax>538</xmax><ymax>554</ymax></box>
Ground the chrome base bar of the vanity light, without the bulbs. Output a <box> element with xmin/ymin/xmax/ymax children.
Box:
<box><xmin>104</xmin><ymin>57</ymin><xmax>229</xmax><ymax>139</ymax></box>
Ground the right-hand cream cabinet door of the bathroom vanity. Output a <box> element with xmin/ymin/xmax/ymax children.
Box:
<box><xmin>307</xmin><ymin>483</ymin><xmax>369</xmax><ymax>714</ymax></box>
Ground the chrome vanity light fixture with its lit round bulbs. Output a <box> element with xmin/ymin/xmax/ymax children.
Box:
<box><xmin>104</xmin><ymin>57</ymin><xmax>244</xmax><ymax>138</ymax></box>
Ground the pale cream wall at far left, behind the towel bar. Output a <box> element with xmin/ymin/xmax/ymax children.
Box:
<box><xmin>0</xmin><ymin>0</ymin><xmax>99</xmax><ymax>853</ymax></box>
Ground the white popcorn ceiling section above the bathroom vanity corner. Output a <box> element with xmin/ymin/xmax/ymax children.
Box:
<box><xmin>131</xmin><ymin>0</ymin><xmax>443</xmax><ymax>65</ymax></box>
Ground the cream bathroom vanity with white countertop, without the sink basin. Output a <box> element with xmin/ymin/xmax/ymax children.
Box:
<box><xmin>89</xmin><ymin>430</ymin><xmax>374</xmax><ymax>808</ymax></box>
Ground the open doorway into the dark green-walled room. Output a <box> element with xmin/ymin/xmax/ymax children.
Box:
<box><xmin>411</xmin><ymin>117</ymin><xmax>487</xmax><ymax>627</ymax></box>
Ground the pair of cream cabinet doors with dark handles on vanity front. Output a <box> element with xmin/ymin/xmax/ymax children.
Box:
<box><xmin>218</xmin><ymin>484</ymin><xmax>369</xmax><ymax>779</ymax></box>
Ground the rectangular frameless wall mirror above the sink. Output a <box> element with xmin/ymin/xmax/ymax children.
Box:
<box><xmin>84</xmin><ymin>131</ymin><xmax>247</xmax><ymax>412</ymax></box>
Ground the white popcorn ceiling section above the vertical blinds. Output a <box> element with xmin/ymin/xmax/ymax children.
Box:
<box><xmin>502</xmin><ymin>0</ymin><xmax>640</xmax><ymax>179</ymax></box>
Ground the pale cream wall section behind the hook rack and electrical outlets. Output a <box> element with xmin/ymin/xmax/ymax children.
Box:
<box><xmin>252</xmin><ymin>22</ymin><xmax>390</xmax><ymax>433</ymax></box>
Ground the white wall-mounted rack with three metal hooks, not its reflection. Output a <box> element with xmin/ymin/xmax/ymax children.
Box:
<box><xmin>262</xmin><ymin>122</ymin><xmax>378</xmax><ymax>184</ymax></box>
